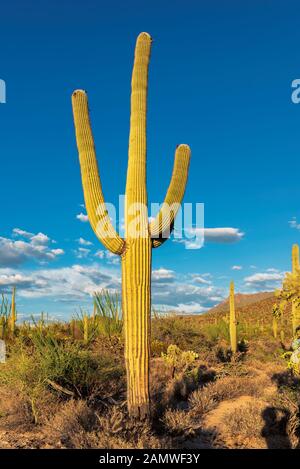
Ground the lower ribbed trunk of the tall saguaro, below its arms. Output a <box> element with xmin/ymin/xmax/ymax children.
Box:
<box><xmin>122</xmin><ymin>239</ymin><xmax>152</xmax><ymax>419</ymax></box>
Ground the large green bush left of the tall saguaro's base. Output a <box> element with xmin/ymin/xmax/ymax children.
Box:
<box><xmin>0</xmin><ymin>333</ymin><xmax>123</xmax><ymax>421</ymax></box>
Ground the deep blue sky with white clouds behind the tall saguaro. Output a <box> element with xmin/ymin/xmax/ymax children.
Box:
<box><xmin>0</xmin><ymin>0</ymin><xmax>300</xmax><ymax>317</ymax></box>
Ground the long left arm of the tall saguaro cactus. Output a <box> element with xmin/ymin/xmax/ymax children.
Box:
<box><xmin>72</xmin><ymin>90</ymin><xmax>125</xmax><ymax>254</ymax></box>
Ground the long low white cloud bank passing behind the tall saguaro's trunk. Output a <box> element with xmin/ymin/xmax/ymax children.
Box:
<box><xmin>0</xmin><ymin>262</ymin><xmax>227</xmax><ymax>314</ymax></box>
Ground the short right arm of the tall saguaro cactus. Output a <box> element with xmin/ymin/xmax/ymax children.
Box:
<box><xmin>149</xmin><ymin>145</ymin><xmax>191</xmax><ymax>248</ymax></box>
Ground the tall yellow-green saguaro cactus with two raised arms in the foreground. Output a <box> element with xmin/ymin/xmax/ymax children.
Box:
<box><xmin>72</xmin><ymin>33</ymin><xmax>190</xmax><ymax>418</ymax></box>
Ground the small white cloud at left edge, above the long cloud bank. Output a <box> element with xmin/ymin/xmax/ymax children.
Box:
<box><xmin>0</xmin><ymin>228</ymin><xmax>64</xmax><ymax>267</ymax></box>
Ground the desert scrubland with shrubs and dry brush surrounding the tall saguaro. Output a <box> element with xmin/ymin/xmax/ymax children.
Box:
<box><xmin>0</xmin><ymin>274</ymin><xmax>300</xmax><ymax>449</ymax></box>
